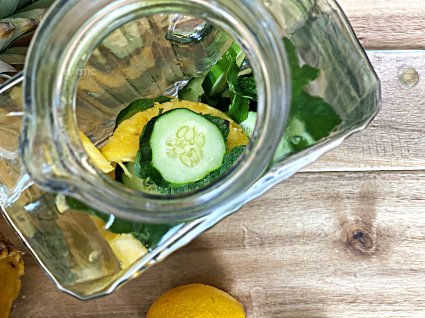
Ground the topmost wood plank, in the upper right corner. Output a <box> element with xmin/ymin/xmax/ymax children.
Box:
<box><xmin>338</xmin><ymin>0</ymin><xmax>425</xmax><ymax>49</ymax></box>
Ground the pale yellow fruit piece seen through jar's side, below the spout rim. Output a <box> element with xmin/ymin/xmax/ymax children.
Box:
<box><xmin>91</xmin><ymin>216</ymin><xmax>147</xmax><ymax>269</ymax></box>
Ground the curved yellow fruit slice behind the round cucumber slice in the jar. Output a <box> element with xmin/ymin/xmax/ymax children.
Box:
<box><xmin>102</xmin><ymin>99</ymin><xmax>249</xmax><ymax>162</ymax></box>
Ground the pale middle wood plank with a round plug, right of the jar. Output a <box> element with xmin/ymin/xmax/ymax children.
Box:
<box><xmin>306</xmin><ymin>51</ymin><xmax>425</xmax><ymax>171</ymax></box>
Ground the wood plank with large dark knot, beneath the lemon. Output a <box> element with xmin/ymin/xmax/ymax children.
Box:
<box><xmin>6</xmin><ymin>172</ymin><xmax>425</xmax><ymax>318</ymax></box>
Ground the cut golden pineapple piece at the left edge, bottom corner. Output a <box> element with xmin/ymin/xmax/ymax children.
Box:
<box><xmin>0</xmin><ymin>234</ymin><xmax>24</xmax><ymax>318</ymax></box>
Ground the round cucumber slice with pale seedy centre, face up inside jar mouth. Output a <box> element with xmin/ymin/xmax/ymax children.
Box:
<box><xmin>136</xmin><ymin>109</ymin><xmax>226</xmax><ymax>186</ymax></box>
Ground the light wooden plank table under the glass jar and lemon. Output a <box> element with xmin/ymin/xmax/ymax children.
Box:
<box><xmin>0</xmin><ymin>0</ymin><xmax>425</xmax><ymax>318</ymax></box>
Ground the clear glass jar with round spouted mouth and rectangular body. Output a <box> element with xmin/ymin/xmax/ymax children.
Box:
<box><xmin>0</xmin><ymin>0</ymin><xmax>380</xmax><ymax>299</ymax></box>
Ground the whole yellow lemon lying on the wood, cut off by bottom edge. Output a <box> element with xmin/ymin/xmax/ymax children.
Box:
<box><xmin>147</xmin><ymin>284</ymin><xmax>245</xmax><ymax>318</ymax></box>
